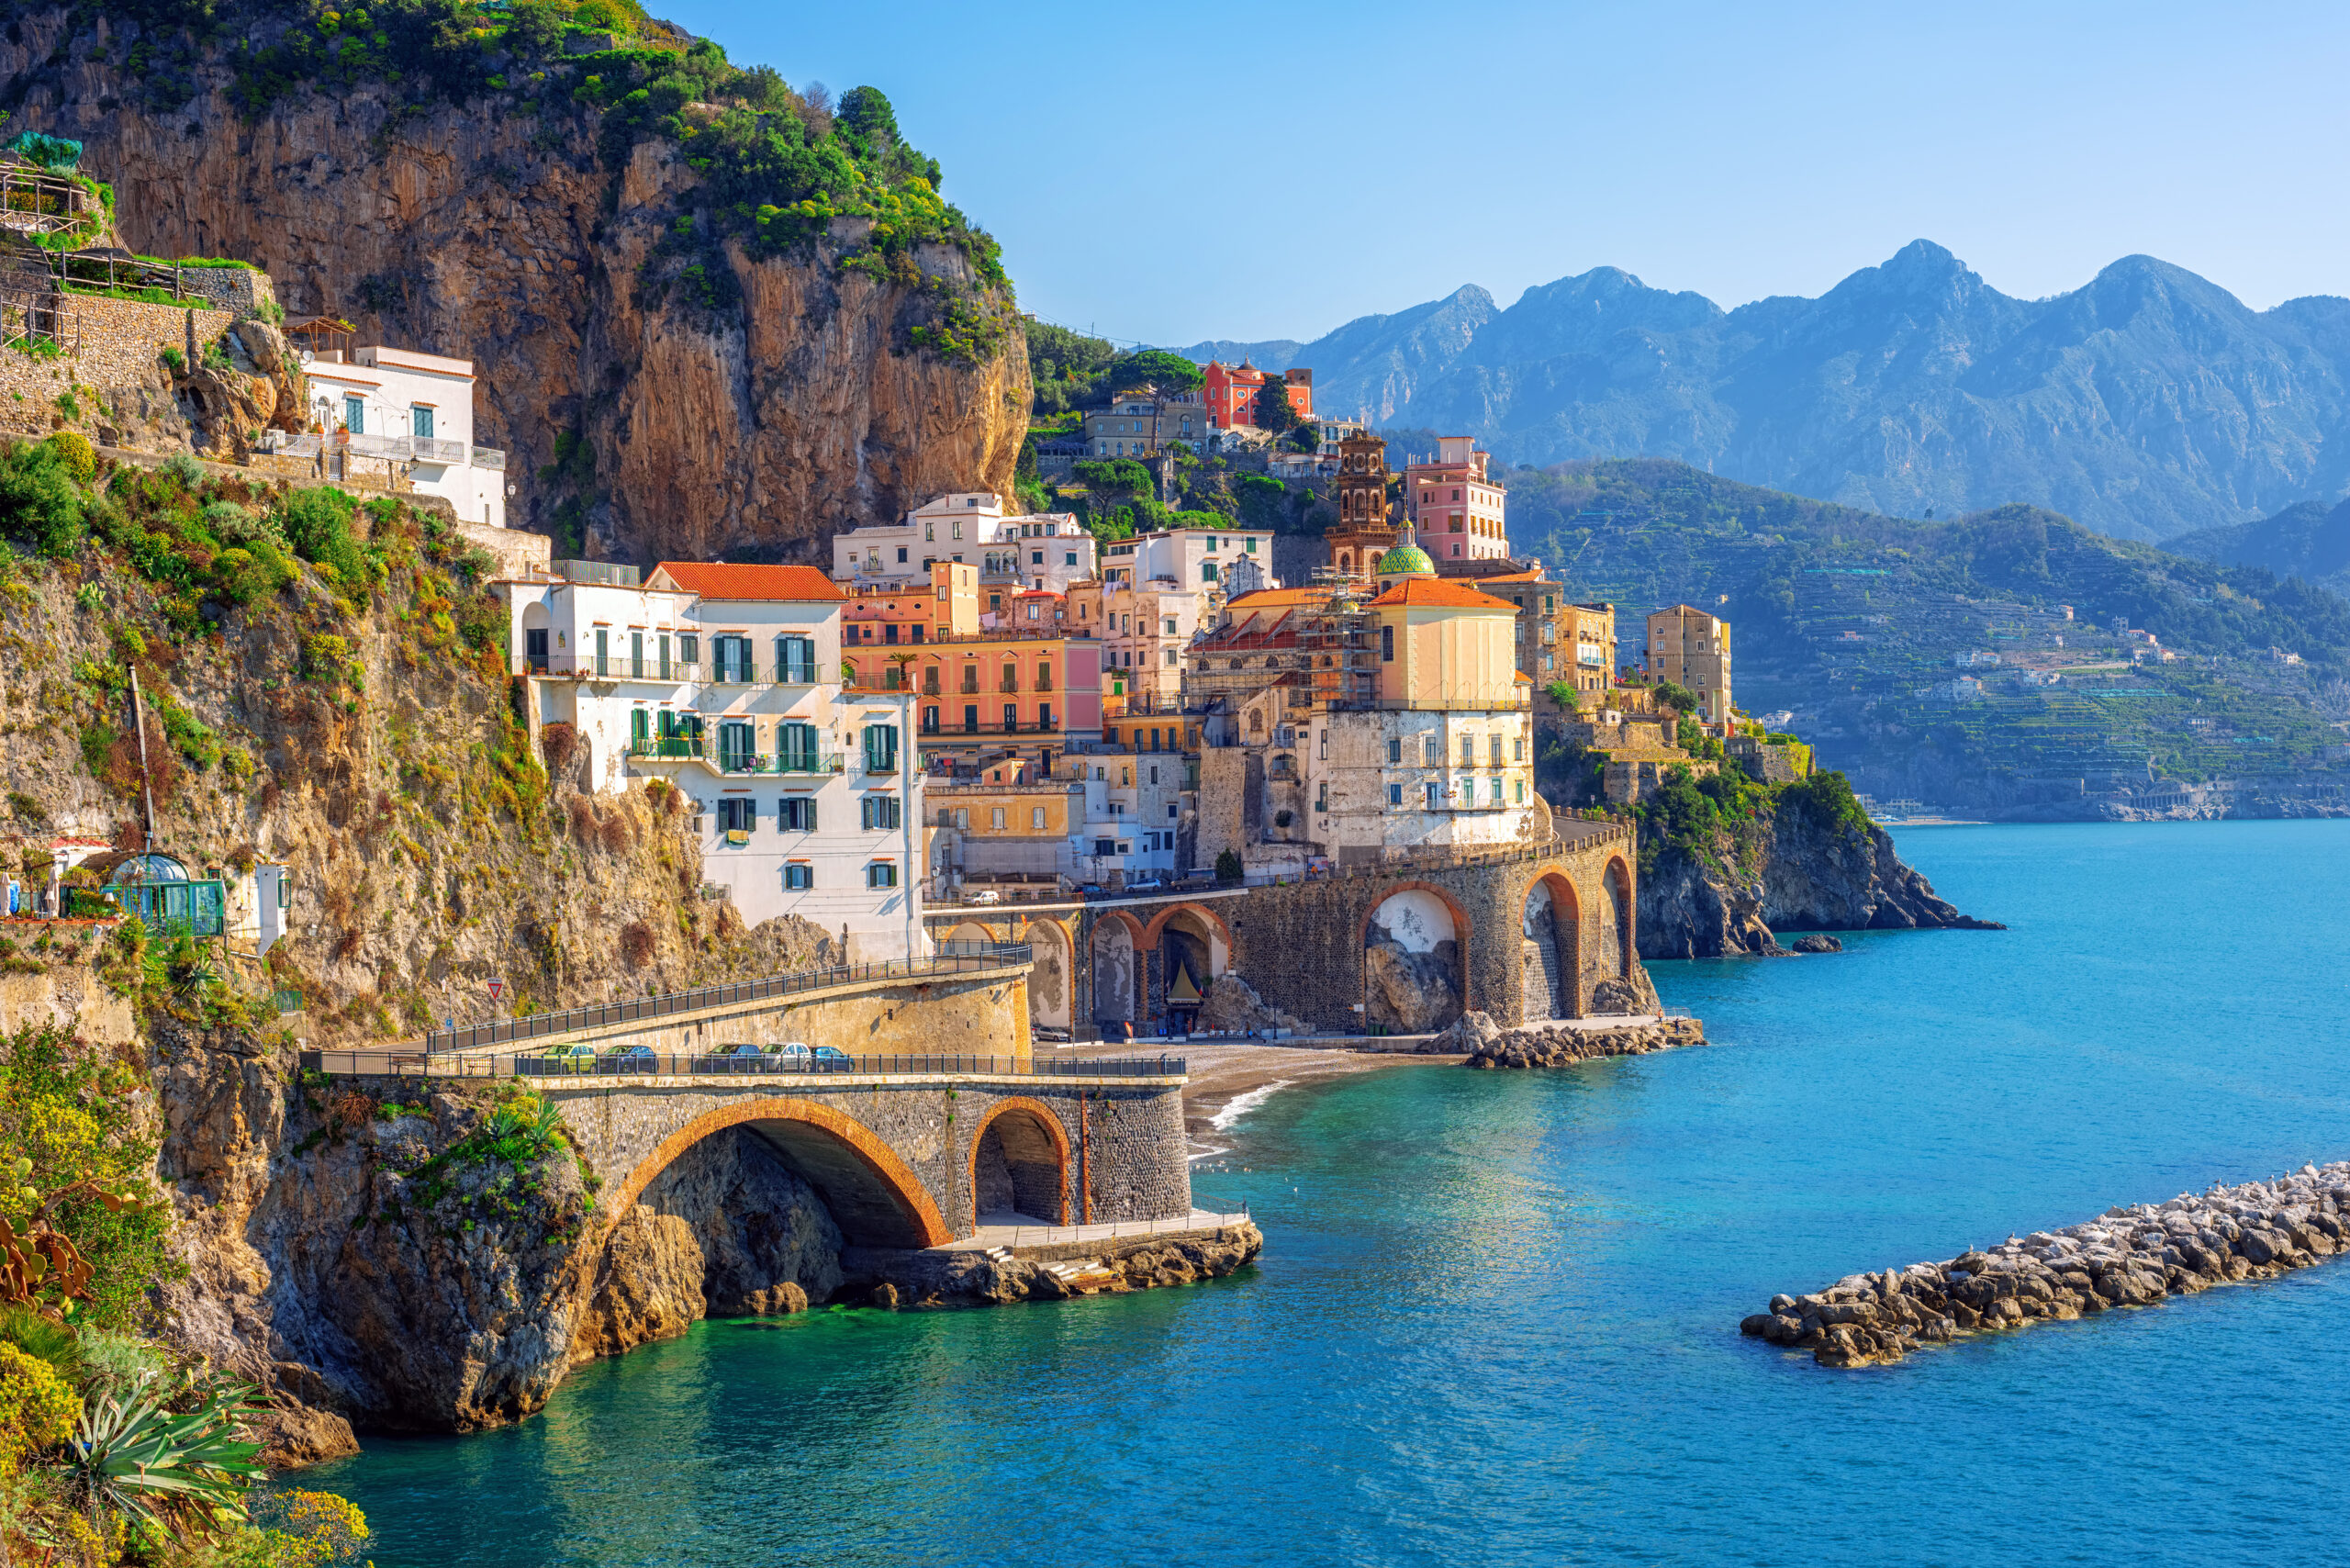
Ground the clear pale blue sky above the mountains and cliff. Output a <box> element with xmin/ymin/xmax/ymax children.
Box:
<box><xmin>654</xmin><ymin>0</ymin><xmax>2350</xmax><ymax>343</ymax></box>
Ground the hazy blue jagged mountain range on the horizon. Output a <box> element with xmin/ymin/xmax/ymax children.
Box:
<box><xmin>1182</xmin><ymin>240</ymin><xmax>2350</xmax><ymax>541</ymax></box>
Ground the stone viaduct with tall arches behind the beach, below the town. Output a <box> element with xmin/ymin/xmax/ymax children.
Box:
<box><xmin>923</xmin><ymin>821</ymin><xmax>1654</xmax><ymax>1039</ymax></box>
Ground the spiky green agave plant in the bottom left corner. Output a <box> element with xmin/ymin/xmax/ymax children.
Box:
<box><xmin>66</xmin><ymin>1384</ymin><xmax>265</xmax><ymax>1535</ymax></box>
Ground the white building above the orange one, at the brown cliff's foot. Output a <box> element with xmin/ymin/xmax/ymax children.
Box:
<box><xmin>832</xmin><ymin>489</ymin><xmax>1095</xmax><ymax>609</ymax></box>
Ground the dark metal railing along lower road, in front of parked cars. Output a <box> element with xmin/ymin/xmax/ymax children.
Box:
<box><xmin>301</xmin><ymin>1047</ymin><xmax>1187</xmax><ymax>1079</ymax></box>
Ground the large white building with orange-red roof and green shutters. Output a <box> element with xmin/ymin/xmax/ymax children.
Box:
<box><xmin>500</xmin><ymin>562</ymin><xmax>923</xmax><ymax>961</ymax></box>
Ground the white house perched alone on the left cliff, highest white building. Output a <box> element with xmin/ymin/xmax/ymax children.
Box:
<box><xmin>296</xmin><ymin>343</ymin><xmax>505</xmax><ymax>529</ymax></box>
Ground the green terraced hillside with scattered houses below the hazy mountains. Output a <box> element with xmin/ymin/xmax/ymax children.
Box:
<box><xmin>1506</xmin><ymin>461</ymin><xmax>2350</xmax><ymax>811</ymax></box>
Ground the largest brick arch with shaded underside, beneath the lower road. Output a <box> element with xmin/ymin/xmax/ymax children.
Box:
<box><xmin>601</xmin><ymin>1098</ymin><xmax>954</xmax><ymax>1246</ymax></box>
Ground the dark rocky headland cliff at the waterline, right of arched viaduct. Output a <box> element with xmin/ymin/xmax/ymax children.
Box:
<box><xmin>1640</xmin><ymin>801</ymin><xmax>2000</xmax><ymax>959</ymax></box>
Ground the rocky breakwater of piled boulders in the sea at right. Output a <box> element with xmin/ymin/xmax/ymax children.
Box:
<box><xmin>1739</xmin><ymin>1161</ymin><xmax>2350</xmax><ymax>1366</ymax></box>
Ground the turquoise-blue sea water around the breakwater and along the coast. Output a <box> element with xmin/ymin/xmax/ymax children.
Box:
<box><xmin>301</xmin><ymin>823</ymin><xmax>2350</xmax><ymax>1568</ymax></box>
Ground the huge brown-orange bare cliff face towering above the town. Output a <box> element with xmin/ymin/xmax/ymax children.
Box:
<box><xmin>0</xmin><ymin>9</ymin><xmax>1029</xmax><ymax>559</ymax></box>
